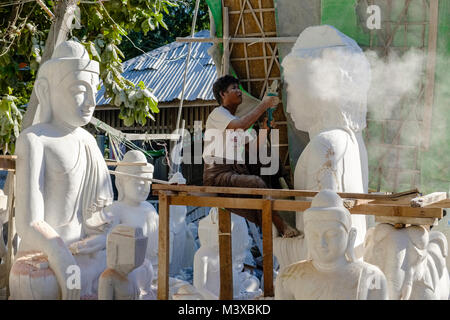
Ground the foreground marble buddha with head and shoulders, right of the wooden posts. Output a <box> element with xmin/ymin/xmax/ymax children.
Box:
<box><xmin>275</xmin><ymin>190</ymin><xmax>387</xmax><ymax>300</ymax></box>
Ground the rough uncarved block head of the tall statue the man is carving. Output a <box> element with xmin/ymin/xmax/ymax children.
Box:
<box><xmin>282</xmin><ymin>25</ymin><xmax>371</xmax><ymax>136</ymax></box>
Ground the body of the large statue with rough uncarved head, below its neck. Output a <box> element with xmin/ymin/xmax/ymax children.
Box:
<box><xmin>273</xmin><ymin>128</ymin><xmax>367</xmax><ymax>267</ymax></box>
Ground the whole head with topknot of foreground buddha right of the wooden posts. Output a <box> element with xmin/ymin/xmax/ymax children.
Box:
<box><xmin>304</xmin><ymin>190</ymin><xmax>356</xmax><ymax>266</ymax></box>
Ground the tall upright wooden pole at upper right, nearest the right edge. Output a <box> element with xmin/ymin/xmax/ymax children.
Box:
<box><xmin>422</xmin><ymin>0</ymin><xmax>439</xmax><ymax>150</ymax></box>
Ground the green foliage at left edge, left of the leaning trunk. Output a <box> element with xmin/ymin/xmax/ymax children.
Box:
<box><xmin>0</xmin><ymin>3</ymin><xmax>51</xmax><ymax>154</ymax></box>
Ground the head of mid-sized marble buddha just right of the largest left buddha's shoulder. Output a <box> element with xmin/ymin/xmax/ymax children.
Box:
<box><xmin>116</xmin><ymin>150</ymin><xmax>154</xmax><ymax>203</ymax></box>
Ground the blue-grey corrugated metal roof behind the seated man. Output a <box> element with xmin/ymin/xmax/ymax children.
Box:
<box><xmin>97</xmin><ymin>30</ymin><xmax>217</xmax><ymax>105</ymax></box>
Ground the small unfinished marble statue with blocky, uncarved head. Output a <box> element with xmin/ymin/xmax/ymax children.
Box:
<box><xmin>98</xmin><ymin>225</ymin><xmax>148</xmax><ymax>300</ymax></box>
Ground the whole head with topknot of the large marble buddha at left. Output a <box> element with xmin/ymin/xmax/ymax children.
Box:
<box><xmin>35</xmin><ymin>41</ymin><xmax>99</xmax><ymax>127</ymax></box>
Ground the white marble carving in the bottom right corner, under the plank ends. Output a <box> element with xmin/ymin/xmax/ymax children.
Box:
<box><xmin>364</xmin><ymin>223</ymin><xmax>450</xmax><ymax>300</ymax></box>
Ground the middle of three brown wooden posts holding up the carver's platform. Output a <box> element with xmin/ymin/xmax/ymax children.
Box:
<box><xmin>219</xmin><ymin>208</ymin><xmax>233</xmax><ymax>300</ymax></box>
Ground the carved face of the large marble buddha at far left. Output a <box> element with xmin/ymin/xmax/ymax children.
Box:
<box><xmin>50</xmin><ymin>71</ymin><xmax>99</xmax><ymax>127</ymax></box>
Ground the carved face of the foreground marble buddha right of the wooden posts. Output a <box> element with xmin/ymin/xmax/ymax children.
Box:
<box><xmin>305</xmin><ymin>220</ymin><xmax>348</xmax><ymax>263</ymax></box>
